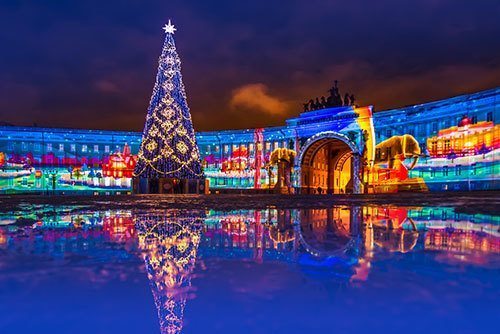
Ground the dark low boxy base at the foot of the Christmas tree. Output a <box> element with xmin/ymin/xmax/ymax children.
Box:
<box><xmin>133</xmin><ymin>178</ymin><xmax>209</xmax><ymax>195</ymax></box>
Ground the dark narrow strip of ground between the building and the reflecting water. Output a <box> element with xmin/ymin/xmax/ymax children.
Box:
<box><xmin>0</xmin><ymin>191</ymin><xmax>500</xmax><ymax>215</ymax></box>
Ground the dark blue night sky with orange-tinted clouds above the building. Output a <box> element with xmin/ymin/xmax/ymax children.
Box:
<box><xmin>0</xmin><ymin>0</ymin><xmax>500</xmax><ymax>131</ymax></box>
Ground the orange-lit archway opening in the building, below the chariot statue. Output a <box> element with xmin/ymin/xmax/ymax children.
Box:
<box><xmin>297</xmin><ymin>131</ymin><xmax>361</xmax><ymax>193</ymax></box>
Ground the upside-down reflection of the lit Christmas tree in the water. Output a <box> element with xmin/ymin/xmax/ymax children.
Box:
<box><xmin>136</xmin><ymin>211</ymin><xmax>204</xmax><ymax>333</ymax></box>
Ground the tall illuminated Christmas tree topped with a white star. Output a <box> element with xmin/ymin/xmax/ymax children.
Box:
<box><xmin>134</xmin><ymin>20</ymin><xmax>204</xmax><ymax>193</ymax></box>
